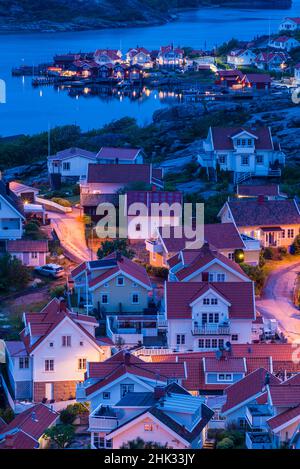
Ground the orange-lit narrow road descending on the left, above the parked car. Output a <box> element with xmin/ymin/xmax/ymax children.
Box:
<box><xmin>47</xmin><ymin>208</ymin><xmax>91</xmax><ymax>263</ymax></box>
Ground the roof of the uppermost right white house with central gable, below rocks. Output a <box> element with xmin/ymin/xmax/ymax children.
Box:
<box><xmin>211</xmin><ymin>127</ymin><xmax>273</xmax><ymax>150</ymax></box>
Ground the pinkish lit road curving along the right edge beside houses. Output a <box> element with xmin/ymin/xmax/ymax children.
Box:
<box><xmin>256</xmin><ymin>259</ymin><xmax>300</xmax><ymax>342</ymax></box>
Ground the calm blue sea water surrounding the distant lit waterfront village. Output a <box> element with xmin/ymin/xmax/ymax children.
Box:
<box><xmin>0</xmin><ymin>0</ymin><xmax>300</xmax><ymax>136</ymax></box>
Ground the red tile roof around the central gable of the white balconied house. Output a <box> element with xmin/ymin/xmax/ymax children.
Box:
<box><xmin>166</xmin><ymin>282</ymin><xmax>255</xmax><ymax>319</ymax></box>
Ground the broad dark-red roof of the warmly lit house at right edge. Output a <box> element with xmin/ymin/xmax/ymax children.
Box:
<box><xmin>227</xmin><ymin>199</ymin><xmax>300</xmax><ymax>227</ymax></box>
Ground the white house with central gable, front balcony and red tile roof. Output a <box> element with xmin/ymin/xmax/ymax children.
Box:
<box><xmin>164</xmin><ymin>280</ymin><xmax>255</xmax><ymax>351</ymax></box>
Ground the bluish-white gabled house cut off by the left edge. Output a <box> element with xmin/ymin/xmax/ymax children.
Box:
<box><xmin>0</xmin><ymin>180</ymin><xmax>25</xmax><ymax>241</ymax></box>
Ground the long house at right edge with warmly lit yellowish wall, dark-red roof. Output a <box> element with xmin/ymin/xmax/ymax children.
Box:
<box><xmin>218</xmin><ymin>196</ymin><xmax>300</xmax><ymax>248</ymax></box>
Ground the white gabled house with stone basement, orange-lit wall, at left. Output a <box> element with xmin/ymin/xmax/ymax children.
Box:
<box><xmin>5</xmin><ymin>298</ymin><xmax>110</xmax><ymax>402</ymax></box>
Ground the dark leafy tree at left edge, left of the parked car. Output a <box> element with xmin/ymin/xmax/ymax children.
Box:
<box><xmin>0</xmin><ymin>253</ymin><xmax>30</xmax><ymax>292</ymax></box>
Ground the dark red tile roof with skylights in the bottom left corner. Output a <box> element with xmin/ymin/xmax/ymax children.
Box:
<box><xmin>1</xmin><ymin>404</ymin><xmax>59</xmax><ymax>449</ymax></box>
